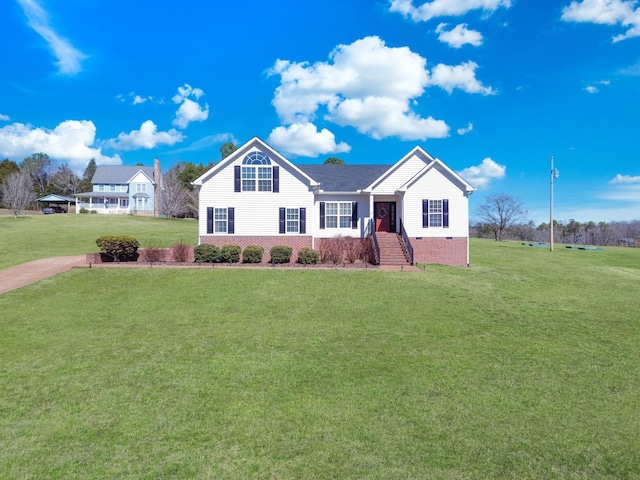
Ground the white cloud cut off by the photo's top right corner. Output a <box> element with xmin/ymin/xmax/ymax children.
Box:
<box><xmin>561</xmin><ymin>0</ymin><xmax>640</xmax><ymax>42</ymax></box>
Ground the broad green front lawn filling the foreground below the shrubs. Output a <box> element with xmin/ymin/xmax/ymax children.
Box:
<box><xmin>0</xmin><ymin>240</ymin><xmax>640</xmax><ymax>479</ymax></box>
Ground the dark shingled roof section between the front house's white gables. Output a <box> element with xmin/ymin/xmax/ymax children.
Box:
<box><xmin>296</xmin><ymin>164</ymin><xmax>391</xmax><ymax>192</ymax></box>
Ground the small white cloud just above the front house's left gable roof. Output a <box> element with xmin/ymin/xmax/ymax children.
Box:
<box><xmin>267</xmin><ymin>123</ymin><xmax>351</xmax><ymax>157</ymax></box>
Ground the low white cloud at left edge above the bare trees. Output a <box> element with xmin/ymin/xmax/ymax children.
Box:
<box><xmin>0</xmin><ymin>120</ymin><xmax>122</xmax><ymax>172</ymax></box>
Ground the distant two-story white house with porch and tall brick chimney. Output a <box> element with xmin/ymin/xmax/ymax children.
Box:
<box><xmin>74</xmin><ymin>159</ymin><xmax>160</xmax><ymax>216</ymax></box>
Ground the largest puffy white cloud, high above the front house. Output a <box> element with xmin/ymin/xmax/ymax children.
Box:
<box><xmin>268</xmin><ymin>36</ymin><xmax>493</xmax><ymax>141</ymax></box>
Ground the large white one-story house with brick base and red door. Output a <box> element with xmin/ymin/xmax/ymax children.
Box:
<box><xmin>193</xmin><ymin>138</ymin><xmax>474</xmax><ymax>266</ymax></box>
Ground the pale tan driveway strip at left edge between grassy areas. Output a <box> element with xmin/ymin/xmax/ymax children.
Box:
<box><xmin>0</xmin><ymin>255</ymin><xmax>86</xmax><ymax>295</ymax></box>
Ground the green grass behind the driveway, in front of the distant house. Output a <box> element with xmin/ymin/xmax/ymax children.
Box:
<box><xmin>0</xmin><ymin>214</ymin><xmax>198</xmax><ymax>269</ymax></box>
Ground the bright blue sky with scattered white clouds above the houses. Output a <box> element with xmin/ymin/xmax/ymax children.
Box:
<box><xmin>0</xmin><ymin>0</ymin><xmax>640</xmax><ymax>224</ymax></box>
